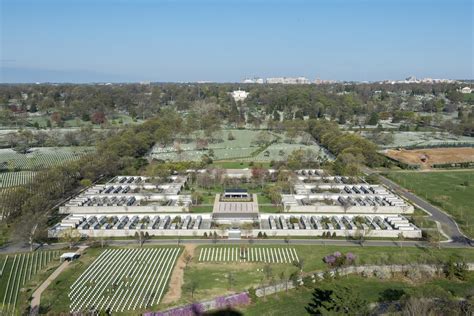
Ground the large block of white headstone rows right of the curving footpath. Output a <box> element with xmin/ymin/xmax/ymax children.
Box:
<box><xmin>68</xmin><ymin>247</ymin><xmax>180</xmax><ymax>313</ymax></box>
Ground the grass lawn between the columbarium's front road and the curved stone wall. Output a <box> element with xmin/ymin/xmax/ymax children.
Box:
<box><xmin>175</xmin><ymin>241</ymin><xmax>474</xmax><ymax>304</ymax></box>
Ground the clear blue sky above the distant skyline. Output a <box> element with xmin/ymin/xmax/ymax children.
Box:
<box><xmin>0</xmin><ymin>0</ymin><xmax>474</xmax><ymax>82</ymax></box>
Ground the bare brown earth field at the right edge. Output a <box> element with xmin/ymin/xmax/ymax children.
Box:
<box><xmin>385</xmin><ymin>147</ymin><xmax>474</xmax><ymax>168</ymax></box>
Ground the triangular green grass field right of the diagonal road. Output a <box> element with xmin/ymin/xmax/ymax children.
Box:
<box><xmin>388</xmin><ymin>171</ymin><xmax>474</xmax><ymax>238</ymax></box>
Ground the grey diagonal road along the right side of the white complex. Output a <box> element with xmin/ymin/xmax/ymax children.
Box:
<box><xmin>364</xmin><ymin>168</ymin><xmax>474</xmax><ymax>246</ymax></box>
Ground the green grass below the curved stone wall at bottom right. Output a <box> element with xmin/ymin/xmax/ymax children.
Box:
<box><xmin>241</xmin><ymin>272</ymin><xmax>474</xmax><ymax>316</ymax></box>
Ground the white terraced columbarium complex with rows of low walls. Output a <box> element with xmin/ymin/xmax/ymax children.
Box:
<box><xmin>48</xmin><ymin>169</ymin><xmax>422</xmax><ymax>239</ymax></box>
